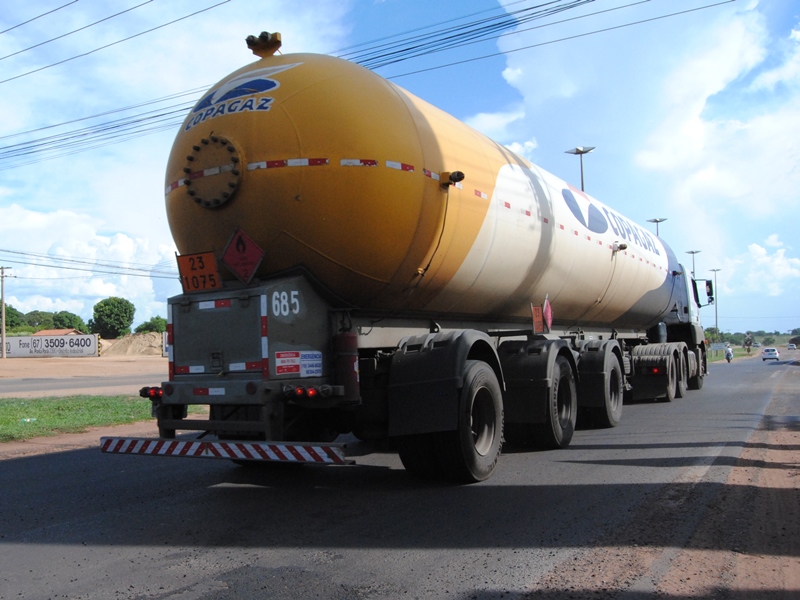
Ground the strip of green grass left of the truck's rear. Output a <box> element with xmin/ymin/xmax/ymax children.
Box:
<box><xmin>0</xmin><ymin>396</ymin><xmax>201</xmax><ymax>442</ymax></box>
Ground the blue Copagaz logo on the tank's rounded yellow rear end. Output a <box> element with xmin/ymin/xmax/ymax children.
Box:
<box><xmin>184</xmin><ymin>63</ymin><xmax>302</xmax><ymax>131</ymax></box>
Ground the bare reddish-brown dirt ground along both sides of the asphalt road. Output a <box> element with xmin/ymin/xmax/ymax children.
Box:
<box><xmin>0</xmin><ymin>347</ymin><xmax>800</xmax><ymax>600</ymax></box>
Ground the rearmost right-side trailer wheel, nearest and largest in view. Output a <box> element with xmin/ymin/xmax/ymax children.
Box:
<box><xmin>437</xmin><ymin>360</ymin><xmax>503</xmax><ymax>483</ymax></box>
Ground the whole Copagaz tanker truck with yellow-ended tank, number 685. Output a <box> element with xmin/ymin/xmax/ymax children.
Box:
<box><xmin>101</xmin><ymin>33</ymin><xmax>707</xmax><ymax>483</ymax></box>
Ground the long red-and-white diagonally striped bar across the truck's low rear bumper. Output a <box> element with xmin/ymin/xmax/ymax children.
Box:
<box><xmin>100</xmin><ymin>437</ymin><xmax>352</xmax><ymax>465</ymax></box>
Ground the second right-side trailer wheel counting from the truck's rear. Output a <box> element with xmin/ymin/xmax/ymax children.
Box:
<box><xmin>537</xmin><ymin>356</ymin><xmax>578</xmax><ymax>449</ymax></box>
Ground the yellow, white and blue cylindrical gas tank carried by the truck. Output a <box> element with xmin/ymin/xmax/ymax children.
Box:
<box><xmin>166</xmin><ymin>42</ymin><xmax>678</xmax><ymax>326</ymax></box>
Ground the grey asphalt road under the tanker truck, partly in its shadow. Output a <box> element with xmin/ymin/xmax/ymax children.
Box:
<box><xmin>0</xmin><ymin>359</ymin><xmax>800</xmax><ymax>600</ymax></box>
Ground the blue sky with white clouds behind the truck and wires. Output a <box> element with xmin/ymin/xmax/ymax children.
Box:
<box><xmin>0</xmin><ymin>0</ymin><xmax>800</xmax><ymax>332</ymax></box>
